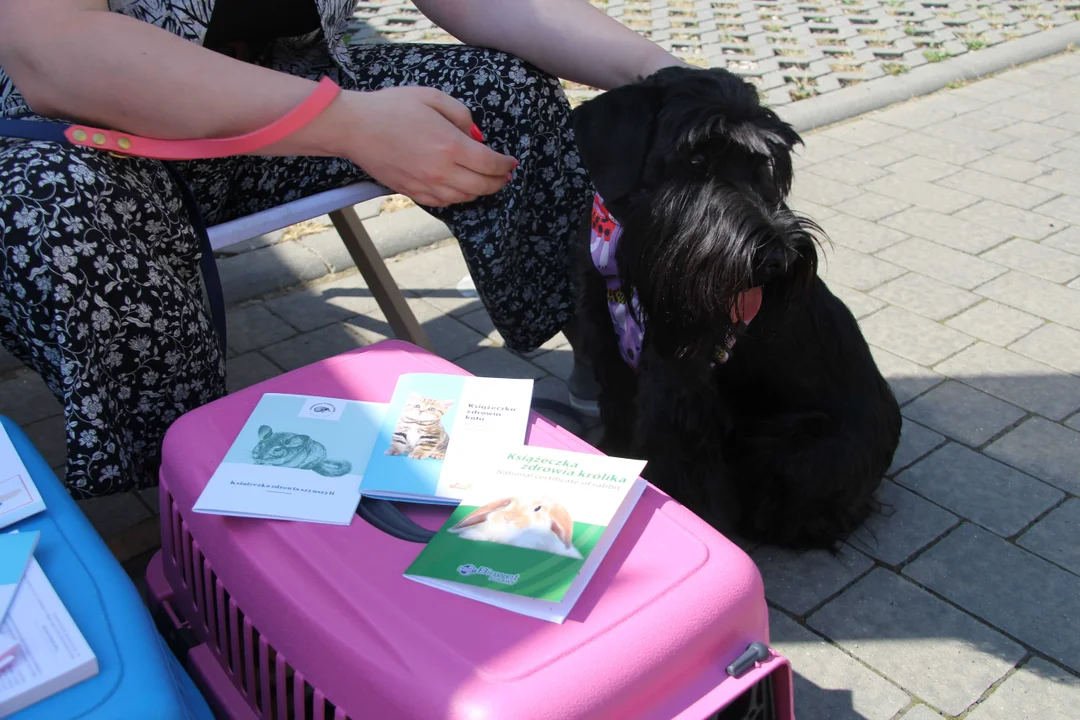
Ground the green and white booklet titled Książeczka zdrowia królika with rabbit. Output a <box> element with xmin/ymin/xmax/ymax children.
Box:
<box><xmin>405</xmin><ymin>447</ymin><xmax>646</xmax><ymax>623</ymax></box>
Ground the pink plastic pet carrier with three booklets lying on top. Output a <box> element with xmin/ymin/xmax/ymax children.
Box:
<box><xmin>148</xmin><ymin>341</ymin><xmax>794</xmax><ymax>720</ymax></box>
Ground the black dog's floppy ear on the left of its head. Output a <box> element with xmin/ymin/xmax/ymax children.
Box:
<box><xmin>570</xmin><ymin>82</ymin><xmax>661</xmax><ymax>202</ymax></box>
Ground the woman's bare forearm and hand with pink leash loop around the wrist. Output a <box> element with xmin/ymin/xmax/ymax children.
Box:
<box><xmin>0</xmin><ymin>0</ymin><xmax>515</xmax><ymax>206</ymax></box>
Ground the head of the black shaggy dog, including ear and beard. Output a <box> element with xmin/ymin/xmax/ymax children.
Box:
<box><xmin>572</xmin><ymin>67</ymin><xmax>821</xmax><ymax>355</ymax></box>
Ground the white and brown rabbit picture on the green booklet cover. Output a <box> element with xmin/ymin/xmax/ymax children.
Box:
<box><xmin>449</xmin><ymin>498</ymin><xmax>581</xmax><ymax>560</ymax></box>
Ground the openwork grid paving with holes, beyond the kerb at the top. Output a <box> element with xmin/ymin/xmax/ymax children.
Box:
<box><xmin>351</xmin><ymin>0</ymin><xmax>1080</xmax><ymax>106</ymax></box>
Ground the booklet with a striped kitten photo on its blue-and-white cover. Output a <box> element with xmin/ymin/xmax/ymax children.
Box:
<box><xmin>360</xmin><ymin>372</ymin><xmax>532</xmax><ymax>504</ymax></box>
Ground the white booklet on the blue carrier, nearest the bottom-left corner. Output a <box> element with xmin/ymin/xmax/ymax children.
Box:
<box><xmin>0</xmin><ymin>559</ymin><xmax>98</xmax><ymax>718</ymax></box>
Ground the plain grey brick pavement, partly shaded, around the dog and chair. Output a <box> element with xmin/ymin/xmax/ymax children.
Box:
<box><xmin>0</xmin><ymin>53</ymin><xmax>1080</xmax><ymax>720</ymax></box>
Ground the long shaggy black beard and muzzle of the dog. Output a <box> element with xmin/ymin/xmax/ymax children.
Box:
<box><xmin>617</xmin><ymin>176</ymin><xmax>821</xmax><ymax>357</ymax></box>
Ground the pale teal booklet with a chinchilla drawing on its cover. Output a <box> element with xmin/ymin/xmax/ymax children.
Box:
<box><xmin>192</xmin><ymin>393</ymin><xmax>387</xmax><ymax>525</ymax></box>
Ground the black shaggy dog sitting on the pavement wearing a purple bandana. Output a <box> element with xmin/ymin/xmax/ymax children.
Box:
<box><xmin>573</xmin><ymin>68</ymin><xmax>901</xmax><ymax>548</ymax></box>
